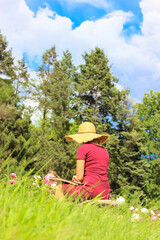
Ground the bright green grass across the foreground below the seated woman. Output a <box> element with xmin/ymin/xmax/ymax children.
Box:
<box><xmin>0</xmin><ymin>174</ymin><xmax>160</xmax><ymax>240</ymax></box>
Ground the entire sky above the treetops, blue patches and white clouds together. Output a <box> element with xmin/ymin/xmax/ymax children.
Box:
<box><xmin>0</xmin><ymin>0</ymin><xmax>160</xmax><ymax>102</ymax></box>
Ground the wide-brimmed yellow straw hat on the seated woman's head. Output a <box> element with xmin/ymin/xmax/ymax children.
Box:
<box><xmin>65</xmin><ymin>122</ymin><xmax>109</xmax><ymax>143</ymax></box>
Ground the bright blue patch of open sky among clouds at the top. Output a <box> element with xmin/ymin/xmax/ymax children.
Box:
<box><xmin>25</xmin><ymin>0</ymin><xmax>143</xmax><ymax>30</ymax></box>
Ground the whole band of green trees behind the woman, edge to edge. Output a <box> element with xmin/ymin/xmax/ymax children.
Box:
<box><xmin>0</xmin><ymin>31</ymin><xmax>160</xmax><ymax>200</ymax></box>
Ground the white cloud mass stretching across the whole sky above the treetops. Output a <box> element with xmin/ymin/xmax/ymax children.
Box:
<box><xmin>0</xmin><ymin>0</ymin><xmax>160</xmax><ymax>100</ymax></box>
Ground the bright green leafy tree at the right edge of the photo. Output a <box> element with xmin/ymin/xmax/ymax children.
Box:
<box><xmin>134</xmin><ymin>90</ymin><xmax>160</xmax><ymax>198</ymax></box>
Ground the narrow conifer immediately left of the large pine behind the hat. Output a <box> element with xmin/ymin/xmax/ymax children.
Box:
<box><xmin>50</xmin><ymin>51</ymin><xmax>76</xmax><ymax>142</ymax></box>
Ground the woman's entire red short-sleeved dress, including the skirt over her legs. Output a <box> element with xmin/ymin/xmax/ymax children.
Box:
<box><xmin>62</xmin><ymin>143</ymin><xmax>111</xmax><ymax>199</ymax></box>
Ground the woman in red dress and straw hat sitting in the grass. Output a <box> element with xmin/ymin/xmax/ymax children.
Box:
<box><xmin>56</xmin><ymin>122</ymin><xmax>111</xmax><ymax>199</ymax></box>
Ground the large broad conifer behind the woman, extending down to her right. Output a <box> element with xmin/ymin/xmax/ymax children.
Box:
<box><xmin>72</xmin><ymin>48</ymin><xmax>148</xmax><ymax>197</ymax></box>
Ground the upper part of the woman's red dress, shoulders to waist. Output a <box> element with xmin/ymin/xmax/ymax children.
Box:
<box><xmin>77</xmin><ymin>143</ymin><xmax>109</xmax><ymax>185</ymax></box>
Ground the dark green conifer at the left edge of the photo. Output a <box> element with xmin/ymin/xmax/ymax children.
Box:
<box><xmin>0</xmin><ymin>34</ymin><xmax>35</xmax><ymax>167</ymax></box>
